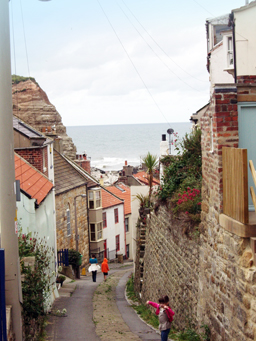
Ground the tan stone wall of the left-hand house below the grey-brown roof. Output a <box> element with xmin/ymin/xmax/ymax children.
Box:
<box><xmin>55</xmin><ymin>186</ymin><xmax>89</xmax><ymax>266</ymax></box>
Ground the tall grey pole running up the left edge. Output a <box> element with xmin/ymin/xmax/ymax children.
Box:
<box><xmin>0</xmin><ymin>0</ymin><xmax>22</xmax><ymax>341</ymax></box>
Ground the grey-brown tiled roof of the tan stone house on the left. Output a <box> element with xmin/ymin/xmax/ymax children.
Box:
<box><xmin>53</xmin><ymin>150</ymin><xmax>99</xmax><ymax>195</ymax></box>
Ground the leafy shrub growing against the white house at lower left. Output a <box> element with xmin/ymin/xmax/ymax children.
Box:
<box><xmin>18</xmin><ymin>231</ymin><xmax>55</xmax><ymax>340</ymax></box>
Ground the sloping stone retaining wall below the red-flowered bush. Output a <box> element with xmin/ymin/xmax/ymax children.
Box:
<box><xmin>141</xmin><ymin>207</ymin><xmax>199</xmax><ymax>328</ymax></box>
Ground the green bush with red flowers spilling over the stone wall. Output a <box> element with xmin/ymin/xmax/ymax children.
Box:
<box><xmin>157</xmin><ymin>129</ymin><xmax>202</xmax><ymax>220</ymax></box>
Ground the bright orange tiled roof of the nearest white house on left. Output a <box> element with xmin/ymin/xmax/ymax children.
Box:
<box><xmin>14</xmin><ymin>153</ymin><xmax>53</xmax><ymax>205</ymax></box>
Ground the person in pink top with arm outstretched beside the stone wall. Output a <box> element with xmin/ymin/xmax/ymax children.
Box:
<box><xmin>147</xmin><ymin>296</ymin><xmax>175</xmax><ymax>341</ymax></box>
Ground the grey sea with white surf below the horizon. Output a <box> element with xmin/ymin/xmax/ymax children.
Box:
<box><xmin>67</xmin><ymin>122</ymin><xmax>191</xmax><ymax>170</ymax></box>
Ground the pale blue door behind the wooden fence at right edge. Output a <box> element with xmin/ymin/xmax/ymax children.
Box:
<box><xmin>238</xmin><ymin>102</ymin><xmax>256</xmax><ymax>211</ymax></box>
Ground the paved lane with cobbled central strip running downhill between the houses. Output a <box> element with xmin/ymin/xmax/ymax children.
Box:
<box><xmin>46</xmin><ymin>264</ymin><xmax>160</xmax><ymax>341</ymax></box>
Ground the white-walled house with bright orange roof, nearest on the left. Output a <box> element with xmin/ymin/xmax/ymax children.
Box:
<box><xmin>14</xmin><ymin>154</ymin><xmax>58</xmax><ymax>304</ymax></box>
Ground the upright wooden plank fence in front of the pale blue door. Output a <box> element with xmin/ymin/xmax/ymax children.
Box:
<box><xmin>222</xmin><ymin>147</ymin><xmax>249</xmax><ymax>224</ymax></box>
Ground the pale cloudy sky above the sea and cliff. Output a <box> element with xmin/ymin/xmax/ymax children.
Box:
<box><xmin>9</xmin><ymin>0</ymin><xmax>245</xmax><ymax>126</ymax></box>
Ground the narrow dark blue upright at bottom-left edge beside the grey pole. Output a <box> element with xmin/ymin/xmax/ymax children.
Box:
<box><xmin>0</xmin><ymin>249</ymin><xmax>7</xmax><ymax>341</ymax></box>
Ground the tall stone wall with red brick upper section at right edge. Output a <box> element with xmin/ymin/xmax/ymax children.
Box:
<box><xmin>197</xmin><ymin>83</ymin><xmax>256</xmax><ymax>341</ymax></box>
